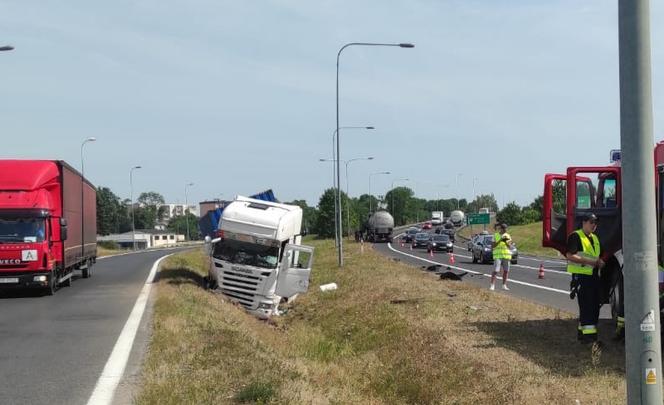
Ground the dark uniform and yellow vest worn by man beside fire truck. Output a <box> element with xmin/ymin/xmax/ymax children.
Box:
<box><xmin>567</xmin><ymin>229</ymin><xmax>601</xmax><ymax>341</ymax></box>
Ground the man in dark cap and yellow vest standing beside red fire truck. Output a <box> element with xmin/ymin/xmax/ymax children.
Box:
<box><xmin>566</xmin><ymin>213</ymin><xmax>604</xmax><ymax>342</ymax></box>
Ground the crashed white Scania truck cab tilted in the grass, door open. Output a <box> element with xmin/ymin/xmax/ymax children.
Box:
<box><xmin>206</xmin><ymin>196</ymin><xmax>314</xmax><ymax>318</ymax></box>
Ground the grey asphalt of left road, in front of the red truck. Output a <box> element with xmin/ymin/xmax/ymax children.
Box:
<box><xmin>0</xmin><ymin>246</ymin><xmax>182</xmax><ymax>404</ymax></box>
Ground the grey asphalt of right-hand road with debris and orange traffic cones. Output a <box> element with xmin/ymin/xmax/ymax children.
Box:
<box><xmin>373</xmin><ymin>226</ymin><xmax>611</xmax><ymax>319</ymax></box>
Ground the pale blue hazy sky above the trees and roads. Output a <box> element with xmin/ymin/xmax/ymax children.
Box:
<box><xmin>0</xmin><ymin>0</ymin><xmax>664</xmax><ymax>205</ymax></box>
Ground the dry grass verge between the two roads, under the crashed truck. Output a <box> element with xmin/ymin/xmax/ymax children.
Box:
<box><xmin>135</xmin><ymin>240</ymin><xmax>625</xmax><ymax>404</ymax></box>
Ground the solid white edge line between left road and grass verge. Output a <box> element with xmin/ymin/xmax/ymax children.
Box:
<box><xmin>88</xmin><ymin>253</ymin><xmax>172</xmax><ymax>405</ymax></box>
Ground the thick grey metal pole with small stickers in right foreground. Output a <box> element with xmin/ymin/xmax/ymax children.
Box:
<box><xmin>618</xmin><ymin>0</ymin><xmax>664</xmax><ymax>405</ymax></box>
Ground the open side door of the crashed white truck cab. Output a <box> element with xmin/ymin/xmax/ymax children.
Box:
<box><xmin>274</xmin><ymin>244</ymin><xmax>314</xmax><ymax>298</ymax></box>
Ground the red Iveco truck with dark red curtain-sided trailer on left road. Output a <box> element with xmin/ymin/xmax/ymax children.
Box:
<box><xmin>0</xmin><ymin>160</ymin><xmax>97</xmax><ymax>295</ymax></box>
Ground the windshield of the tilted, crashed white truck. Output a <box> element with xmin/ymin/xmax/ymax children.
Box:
<box><xmin>212</xmin><ymin>239</ymin><xmax>279</xmax><ymax>269</ymax></box>
